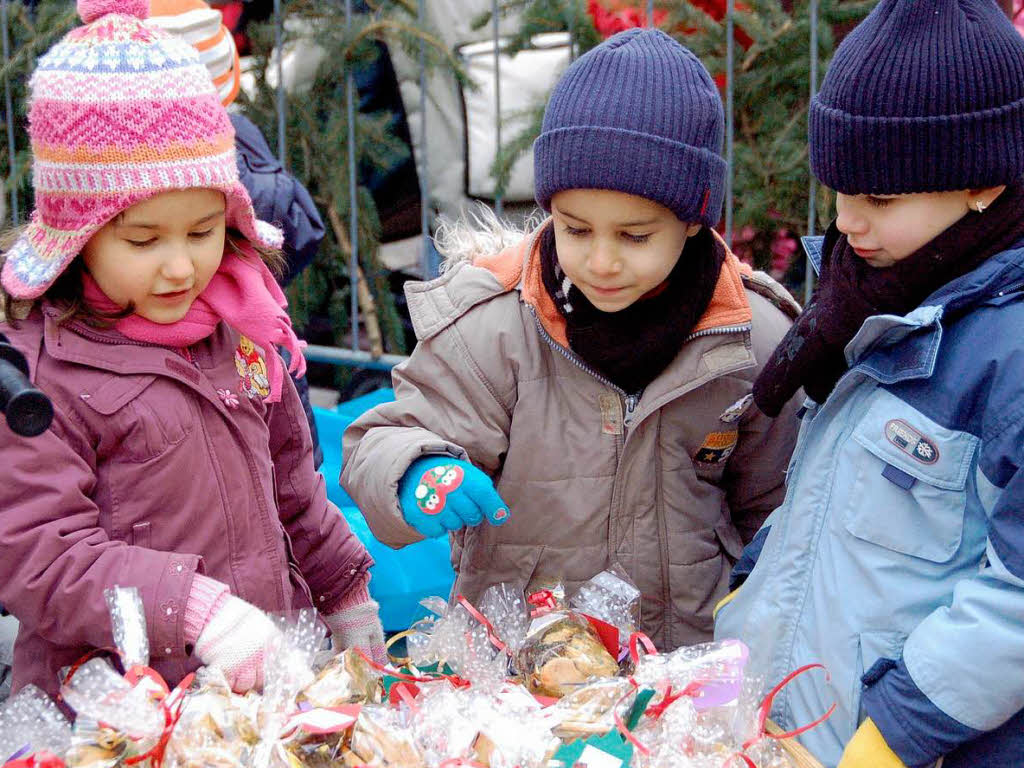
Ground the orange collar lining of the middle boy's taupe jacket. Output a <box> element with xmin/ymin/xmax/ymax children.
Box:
<box><xmin>473</xmin><ymin>218</ymin><xmax>753</xmax><ymax>349</ymax></box>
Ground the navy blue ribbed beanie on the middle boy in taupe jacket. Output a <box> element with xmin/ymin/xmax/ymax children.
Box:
<box><xmin>534</xmin><ymin>29</ymin><xmax>726</xmax><ymax>226</ymax></box>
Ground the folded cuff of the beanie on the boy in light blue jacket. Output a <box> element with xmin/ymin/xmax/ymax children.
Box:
<box><xmin>808</xmin><ymin>96</ymin><xmax>1024</xmax><ymax>195</ymax></box>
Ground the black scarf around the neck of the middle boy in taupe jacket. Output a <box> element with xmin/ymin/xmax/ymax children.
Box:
<box><xmin>541</xmin><ymin>219</ymin><xmax>725</xmax><ymax>394</ymax></box>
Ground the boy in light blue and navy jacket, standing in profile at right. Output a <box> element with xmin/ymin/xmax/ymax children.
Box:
<box><xmin>716</xmin><ymin>0</ymin><xmax>1024</xmax><ymax>768</ymax></box>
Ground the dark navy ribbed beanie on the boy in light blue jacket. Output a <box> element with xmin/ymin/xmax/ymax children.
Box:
<box><xmin>808</xmin><ymin>0</ymin><xmax>1024</xmax><ymax>195</ymax></box>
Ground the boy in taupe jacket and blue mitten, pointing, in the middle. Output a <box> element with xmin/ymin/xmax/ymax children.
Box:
<box><xmin>342</xmin><ymin>30</ymin><xmax>798</xmax><ymax>650</ymax></box>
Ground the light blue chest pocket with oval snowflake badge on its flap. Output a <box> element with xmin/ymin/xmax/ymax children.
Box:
<box><xmin>845</xmin><ymin>387</ymin><xmax>978</xmax><ymax>563</ymax></box>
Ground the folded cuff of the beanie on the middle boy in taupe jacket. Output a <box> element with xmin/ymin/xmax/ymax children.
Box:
<box><xmin>534</xmin><ymin>126</ymin><xmax>728</xmax><ymax>227</ymax></box>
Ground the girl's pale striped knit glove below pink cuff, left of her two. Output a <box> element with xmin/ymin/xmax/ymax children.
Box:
<box><xmin>196</xmin><ymin>595</ymin><xmax>280</xmax><ymax>693</ymax></box>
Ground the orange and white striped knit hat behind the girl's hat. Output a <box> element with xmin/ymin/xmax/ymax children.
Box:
<box><xmin>146</xmin><ymin>0</ymin><xmax>242</xmax><ymax>106</ymax></box>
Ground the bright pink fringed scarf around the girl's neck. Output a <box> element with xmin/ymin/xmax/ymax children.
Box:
<box><xmin>82</xmin><ymin>246</ymin><xmax>306</xmax><ymax>402</ymax></box>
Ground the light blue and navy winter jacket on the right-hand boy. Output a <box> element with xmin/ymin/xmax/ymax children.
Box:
<box><xmin>715</xmin><ymin>243</ymin><xmax>1024</xmax><ymax>768</ymax></box>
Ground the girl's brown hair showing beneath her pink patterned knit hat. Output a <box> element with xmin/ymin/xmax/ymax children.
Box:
<box><xmin>0</xmin><ymin>226</ymin><xmax>285</xmax><ymax>328</ymax></box>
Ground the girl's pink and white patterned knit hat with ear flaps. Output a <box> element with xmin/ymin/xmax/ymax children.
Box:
<box><xmin>0</xmin><ymin>0</ymin><xmax>282</xmax><ymax>299</ymax></box>
